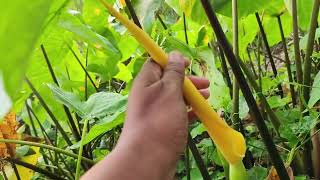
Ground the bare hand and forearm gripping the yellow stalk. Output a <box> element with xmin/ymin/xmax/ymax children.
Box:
<box><xmin>82</xmin><ymin>52</ymin><xmax>209</xmax><ymax>180</ymax></box>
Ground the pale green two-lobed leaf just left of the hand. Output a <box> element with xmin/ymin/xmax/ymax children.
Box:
<box><xmin>48</xmin><ymin>84</ymin><xmax>127</xmax><ymax>120</ymax></box>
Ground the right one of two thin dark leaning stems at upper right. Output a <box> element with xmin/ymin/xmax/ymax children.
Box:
<box><xmin>277</xmin><ymin>16</ymin><xmax>297</xmax><ymax>107</ymax></box>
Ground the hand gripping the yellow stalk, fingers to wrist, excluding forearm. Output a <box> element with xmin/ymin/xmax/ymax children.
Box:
<box><xmin>117</xmin><ymin>52</ymin><xmax>209</xmax><ymax>177</ymax></box>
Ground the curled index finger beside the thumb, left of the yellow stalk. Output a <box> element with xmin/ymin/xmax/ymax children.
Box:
<box><xmin>135</xmin><ymin>59</ymin><xmax>162</xmax><ymax>87</ymax></box>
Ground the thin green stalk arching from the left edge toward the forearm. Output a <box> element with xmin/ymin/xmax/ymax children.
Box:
<box><xmin>0</xmin><ymin>139</ymin><xmax>95</xmax><ymax>165</ymax></box>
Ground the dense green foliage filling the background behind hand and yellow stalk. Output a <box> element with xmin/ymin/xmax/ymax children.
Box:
<box><xmin>0</xmin><ymin>0</ymin><xmax>320</xmax><ymax>179</ymax></box>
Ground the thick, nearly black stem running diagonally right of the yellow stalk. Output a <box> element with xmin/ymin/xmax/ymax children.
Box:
<box><xmin>201</xmin><ymin>0</ymin><xmax>290</xmax><ymax>180</ymax></box>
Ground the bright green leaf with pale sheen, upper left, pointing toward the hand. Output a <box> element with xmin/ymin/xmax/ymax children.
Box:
<box><xmin>59</xmin><ymin>13</ymin><xmax>121</xmax><ymax>59</ymax></box>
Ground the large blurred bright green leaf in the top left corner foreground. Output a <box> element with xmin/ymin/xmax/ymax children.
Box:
<box><xmin>0</xmin><ymin>0</ymin><xmax>51</xmax><ymax>118</ymax></box>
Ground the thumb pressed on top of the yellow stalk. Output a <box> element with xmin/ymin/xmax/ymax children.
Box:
<box><xmin>162</xmin><ymin>52</ymin><xmax>188</xmax><ymax>87</ymax></box>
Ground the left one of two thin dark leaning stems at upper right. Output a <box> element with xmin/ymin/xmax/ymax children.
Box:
<box><xmin>255</xmin><ymin>13</ymin><xmax>283</xmax><ymax>98</ymax></box>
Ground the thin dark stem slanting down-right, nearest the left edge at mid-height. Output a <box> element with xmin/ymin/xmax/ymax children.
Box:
<box><xmin>26</xmin><ymin>78</ymin><xmax>72</xmax><ymax>146</ymax></box>
